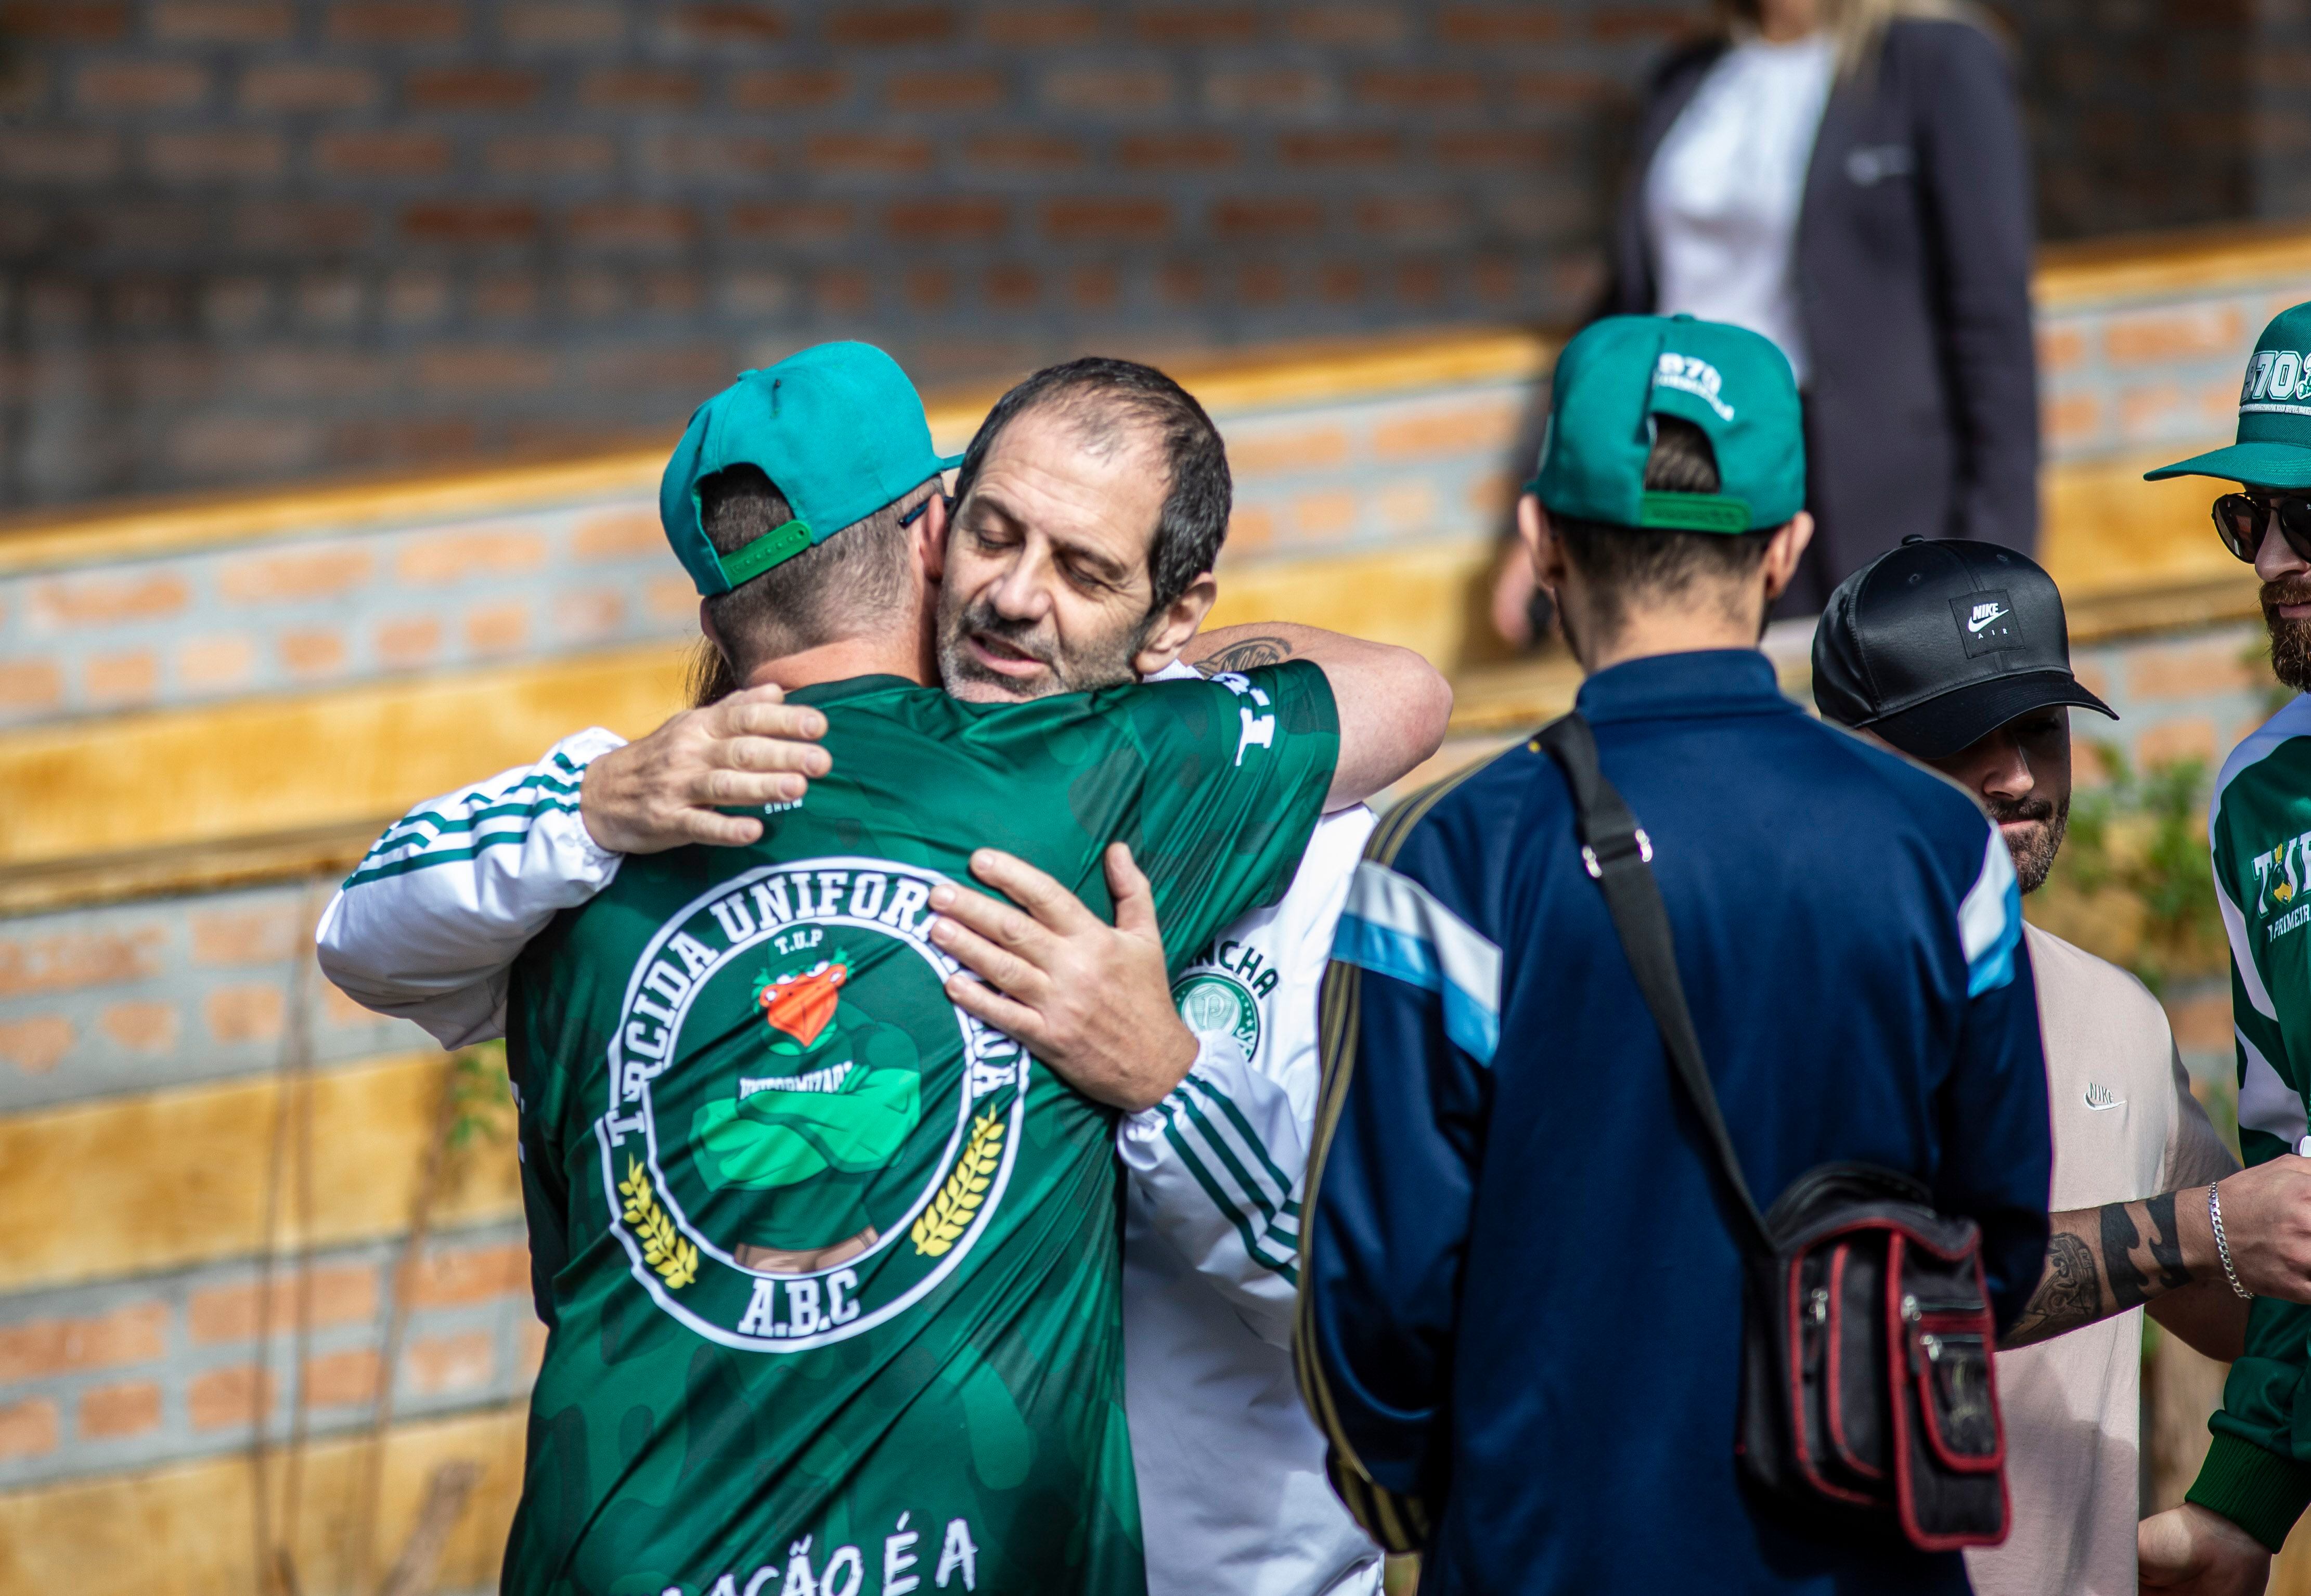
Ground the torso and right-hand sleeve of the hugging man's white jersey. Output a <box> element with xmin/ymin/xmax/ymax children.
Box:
<box><xmin>1116</xmin><ymin>806</ymin><xmax>1379</xmax><ymax>1596</ymax></box>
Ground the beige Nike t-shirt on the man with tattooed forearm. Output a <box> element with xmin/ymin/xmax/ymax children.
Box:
<box><xmin>1967</xmin><ymin>926</ymin><xmax>2239</xmax><ymax>1596</ymax></box>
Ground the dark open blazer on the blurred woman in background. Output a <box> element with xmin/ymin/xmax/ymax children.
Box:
<box><xmin>1606</xmin><ymin>21</ymin><xmax>2038</xmax><ymax>614</ymax></box>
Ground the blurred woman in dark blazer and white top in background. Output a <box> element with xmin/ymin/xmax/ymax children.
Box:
<box><xmin>1495</xmin><ymin>0</ymin><xmax>2038</xmax><ymax>642</ymax></box>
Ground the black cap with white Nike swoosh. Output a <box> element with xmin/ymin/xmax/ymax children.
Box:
<box><xmin>1814</xmin><ymin>538</ymin><xmax>2119</xmax><ymax>760</ymax></box>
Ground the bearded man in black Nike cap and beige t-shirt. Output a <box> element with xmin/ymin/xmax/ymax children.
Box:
<box><xmin>1814</xmin><ymin>538</ymin><xmax>2311</xmax><ymax>1596</ymax></box>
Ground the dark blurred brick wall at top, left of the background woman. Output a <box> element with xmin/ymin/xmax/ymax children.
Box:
<box><xmin>0</xmin><ymin>0</ymin><xmax>1706</xmax><ymax>503</ymax></box>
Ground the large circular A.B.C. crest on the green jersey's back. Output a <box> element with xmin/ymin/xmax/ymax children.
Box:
<box><xmin>594</xmin><ymin>857</ymin><xmax>1026</xmax><ymax>1351</ymax></box>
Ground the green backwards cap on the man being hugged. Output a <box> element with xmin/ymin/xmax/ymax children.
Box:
<box><xmin>659</xmin><ymin>342</ymin><xmax>964</xmax><ymax>598</ymax></box>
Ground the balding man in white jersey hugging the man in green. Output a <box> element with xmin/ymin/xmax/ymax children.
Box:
<box><xmin>321</xmin><ymin>367</ymin><xmax>1396</xmax><ymax>1596</ymax></box>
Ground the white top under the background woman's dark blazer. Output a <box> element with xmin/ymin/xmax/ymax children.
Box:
<box><xmin>1645</xmin><ymin>32</ymin><xmax>1837</xmax><ymax>388</ymax></box>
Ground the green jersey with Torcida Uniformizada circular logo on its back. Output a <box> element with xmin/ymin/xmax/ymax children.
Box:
<box><xmin>504</xmin><ymin>663</ymin><xmax>1338</xmax><ymax>1596</ymax></box>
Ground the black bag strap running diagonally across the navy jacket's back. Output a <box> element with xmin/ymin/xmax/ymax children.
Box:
<box><xmin>1534</xmin><ymin>713</ymin><xmax>1773</xmax><ymax>1256</ymax></box>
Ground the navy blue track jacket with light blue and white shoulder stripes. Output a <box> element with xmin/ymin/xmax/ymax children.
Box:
<box><xmin>1299</xmin><ymin>649</ymin><xmax>2050</xmax><ymax>1596</ymax></box>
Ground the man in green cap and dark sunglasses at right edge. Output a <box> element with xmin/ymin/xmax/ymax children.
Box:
<box><xmin>2140</xmin><ymin>305</ymin><xmax>2311</xmax><ymax>1596</ymax></box>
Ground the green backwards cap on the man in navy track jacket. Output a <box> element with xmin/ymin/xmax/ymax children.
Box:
<box><xmin>1525</xmin><ymin>316</ymin><xmax>1805</xmax><ymax>534</ymax></box>
